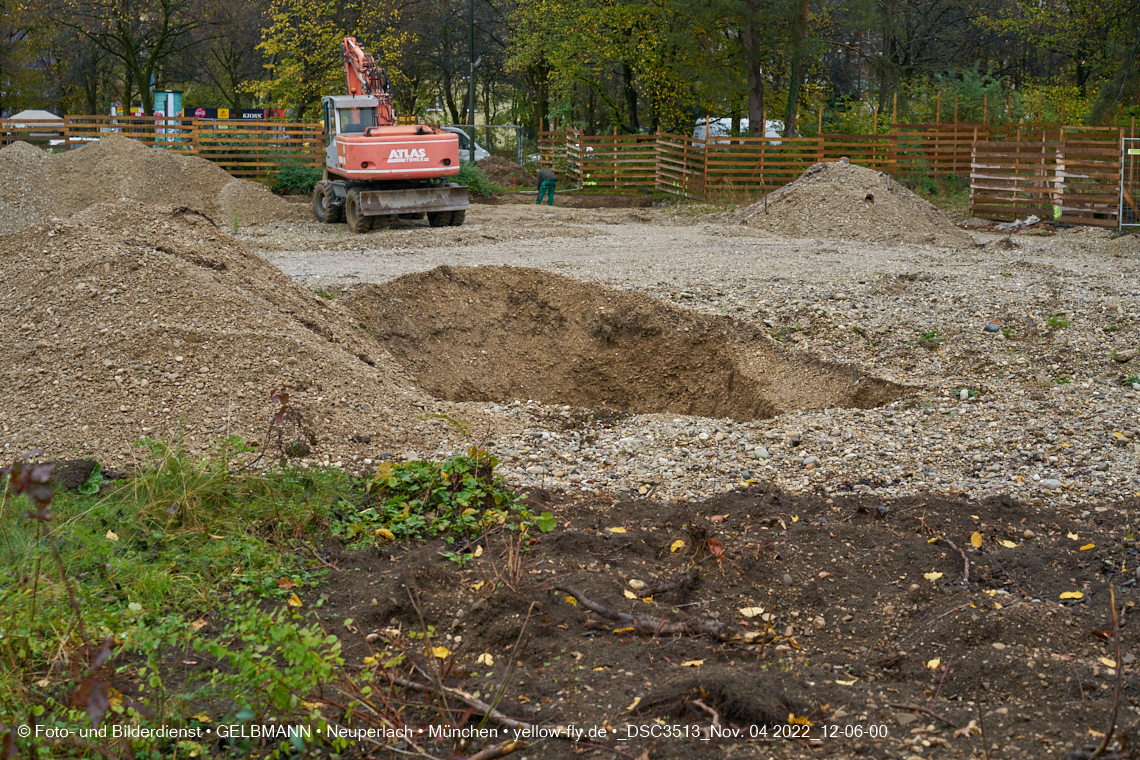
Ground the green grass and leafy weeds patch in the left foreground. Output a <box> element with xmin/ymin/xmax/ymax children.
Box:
<box><xmin>0</xmin><ymin>438</ymin><xmax>542</xmax><ymax>758</ymax></box>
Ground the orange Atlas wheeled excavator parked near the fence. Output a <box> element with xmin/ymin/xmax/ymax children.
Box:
<box><xmin>312</xmin><ymin>36</ymin><xmax>471</xmax><ymax>232</ymax></box>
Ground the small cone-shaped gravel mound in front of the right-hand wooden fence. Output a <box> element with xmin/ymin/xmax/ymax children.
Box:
<box><xmin>734</xmin><ymin>163</ymin><xmax>974</xmax><ymax>247</ymax></box>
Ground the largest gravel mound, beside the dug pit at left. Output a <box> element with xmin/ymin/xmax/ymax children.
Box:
<box><xmin>0</xmin><ymin>202</ymin><xmax>462</xmax><ymax>461</ymax></box>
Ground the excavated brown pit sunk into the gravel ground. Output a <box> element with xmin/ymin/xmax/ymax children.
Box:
<box><xmin>345</xmin><ymin>267</ymin><xmax>905</xmax><ymax>419</ymax></box>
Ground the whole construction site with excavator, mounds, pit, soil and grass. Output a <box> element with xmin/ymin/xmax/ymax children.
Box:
<box><xmin>0</xmin><ymin>53</ymin><xmax>1140</xmax><ymax>760</ymax></box>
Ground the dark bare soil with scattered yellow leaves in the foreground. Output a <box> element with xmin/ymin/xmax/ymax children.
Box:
<box><xmin>314</xmin><ymin>485</ymin><xmax>1137</xmax><ymax>760</ymax></box>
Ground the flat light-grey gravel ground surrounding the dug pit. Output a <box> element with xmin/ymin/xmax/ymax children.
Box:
<box><xmin>233</xmin><ymin>205</ymin><xmax>1140</xmax><ymax>506</ymax></box>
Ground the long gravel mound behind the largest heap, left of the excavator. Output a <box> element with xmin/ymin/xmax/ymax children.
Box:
<box><xmin>0</xmin><ymin>134</ymin><xmax>308</xmax><ymax>234</ymax></box>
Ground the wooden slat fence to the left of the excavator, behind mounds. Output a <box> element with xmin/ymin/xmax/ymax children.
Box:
<box><xmin>0</xmin><ymin>115</ymin><xmax>325</xmax><ymax>179</ymax></box>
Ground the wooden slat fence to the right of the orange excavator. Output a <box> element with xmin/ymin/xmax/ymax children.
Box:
<box><xmin>538</xmin><ymin>122</ymin><xmax>1130</xmax><ymax>227</ymax></box>
